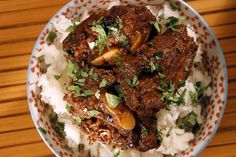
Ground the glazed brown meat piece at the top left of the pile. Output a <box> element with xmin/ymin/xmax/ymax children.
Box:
<box><xmin>63</xmin><ymin>6</ymin><xmax>155</xmax><ymax>63</ymax></box>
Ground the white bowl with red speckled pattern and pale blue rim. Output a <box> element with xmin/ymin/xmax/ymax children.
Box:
<box><xmin>27</xmin><ymin>0</ymin><xmax>228</xmax><ymax>157</ymax></box>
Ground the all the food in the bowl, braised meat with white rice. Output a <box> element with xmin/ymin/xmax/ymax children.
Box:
<box><xmin>38</xmin><ymin>0</ymin><xmax>212</xmax><ymax>156</ymax></box>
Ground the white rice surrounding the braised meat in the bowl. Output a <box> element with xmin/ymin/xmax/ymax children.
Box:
<box><xmin>38</xmin><ymin>2</ymin><xmax>212</xmax><ymax>157</ymax></box>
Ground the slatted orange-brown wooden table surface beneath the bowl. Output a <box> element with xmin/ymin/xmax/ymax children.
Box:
<box><xmin>0</xmin><ymin>0</ymin><xmax>236</xmax><ymax>157</ymax></box>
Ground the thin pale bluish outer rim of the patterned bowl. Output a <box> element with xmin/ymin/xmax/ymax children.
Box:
<box><xmin>26</xmin><ymin>0</ymin><xmax>228</xmax><ymax>157</ymax></box>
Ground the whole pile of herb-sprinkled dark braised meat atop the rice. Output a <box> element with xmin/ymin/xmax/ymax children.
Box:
<box><xmin>63</xmin><ymin>6</ymin><xmax>198</xmax><ymax>151</ymax></box>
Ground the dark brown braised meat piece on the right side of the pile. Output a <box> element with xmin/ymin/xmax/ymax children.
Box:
<box><xmin>116</xmin><ymin>26</ymin><xmax>198</xmax><ymax>116</ymax></box>
